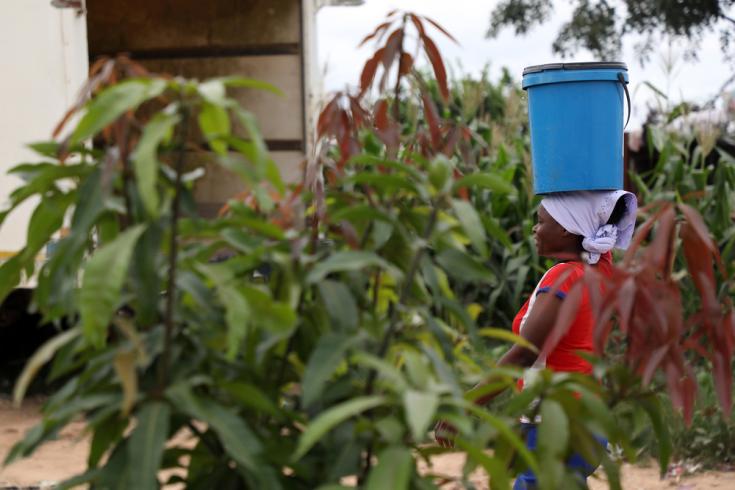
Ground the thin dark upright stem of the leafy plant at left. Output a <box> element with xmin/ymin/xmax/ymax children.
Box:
<box><xmin>158</xmin><ymin>106</ymin><xmax>189</xmax><ymax>391</ymax></box>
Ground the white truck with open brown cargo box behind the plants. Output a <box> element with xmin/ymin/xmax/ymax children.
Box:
<box><xmin>0</xmin><ymin>0</ymin><xmax>361</xmax><ymax>334</ymax></box>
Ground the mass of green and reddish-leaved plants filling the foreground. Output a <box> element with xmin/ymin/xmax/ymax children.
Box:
<box><xmin>0</xmin><ymin>12</ymin><xmax>735</xmax><ymax>490</ymax></box>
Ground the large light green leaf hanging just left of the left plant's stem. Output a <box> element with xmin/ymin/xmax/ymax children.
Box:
<box><xmin>79</xmin><ymin>225</ymin><xmax>145</xmax><ymax>347</ymax></box>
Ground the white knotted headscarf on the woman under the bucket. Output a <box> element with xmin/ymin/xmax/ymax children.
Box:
<box><xmin>541</xmin><ymin>191</ymin><xmax>638</xmax><ymax>264</ymax></box>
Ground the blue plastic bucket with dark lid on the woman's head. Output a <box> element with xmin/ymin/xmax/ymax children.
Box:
<box><xmin>523</xmin><ymin>62</ymin><xmax>630</xmax><ymax>194</ymax></box>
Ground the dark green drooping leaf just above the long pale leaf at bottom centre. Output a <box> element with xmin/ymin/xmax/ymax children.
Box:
<box><xmin>301</xmin><ymin>333</ymin><xmax>360</xmax><ymax>408</ymax></box>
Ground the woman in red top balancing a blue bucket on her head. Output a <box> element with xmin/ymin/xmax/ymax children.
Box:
<box><xmin>435</xmin><ymin>63</ymin><xmax>637</xmax><ymax>490</ymax></box>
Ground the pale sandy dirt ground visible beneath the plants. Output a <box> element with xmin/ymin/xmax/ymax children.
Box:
<box><xmin>0</xmin><ymin>398</ymin><xmax>735</xmax><ymax>490</ymax></box>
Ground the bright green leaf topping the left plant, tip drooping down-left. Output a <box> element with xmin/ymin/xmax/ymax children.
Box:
<box><xmin>69</xmin><ymin>78</ymin><xmax>167</xmax><ymax>145</ymax></box>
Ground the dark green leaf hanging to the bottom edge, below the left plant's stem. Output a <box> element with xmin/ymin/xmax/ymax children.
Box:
<box><xmin>127</xmin><ymin>401</ymin><xmax>171</xmax><ymax>490</ymax></box>
